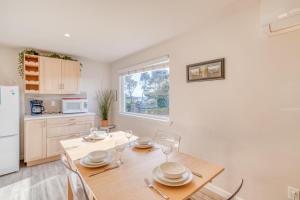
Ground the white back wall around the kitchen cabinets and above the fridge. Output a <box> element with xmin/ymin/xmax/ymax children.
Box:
<box><xmin>0</xmin><ymin>45</ymin><xmax>111</xmax><ymax>157</ymax></box>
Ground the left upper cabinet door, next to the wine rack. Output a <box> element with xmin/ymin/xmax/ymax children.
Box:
<box><xmin>40</xmin><ymin>56</ymin><xmax>62</xmax><ymax>94</ymax></box>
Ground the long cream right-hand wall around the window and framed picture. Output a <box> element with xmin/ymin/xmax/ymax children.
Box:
<box><xmin>112</xmin><ymin>0</ymin><xmax>300</xmax><ymax>200</ymax></box>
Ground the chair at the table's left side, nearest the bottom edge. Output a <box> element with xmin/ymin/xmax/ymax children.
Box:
<box><xmin>61</xmin><ymin>154</ymin><xmax>90</xmax><ymax>200</ymax></box>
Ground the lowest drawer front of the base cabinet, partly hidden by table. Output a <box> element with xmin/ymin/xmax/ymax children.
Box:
<box><xmin>47</xmin><ymin>134</ymin><xmax>80</xmax><ymax>157</ymax></box>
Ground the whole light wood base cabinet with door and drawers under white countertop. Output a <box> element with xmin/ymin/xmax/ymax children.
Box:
<box><xmin>24</xmin><ymin>115</ymin><xmax>95</xmax><ymax>165</ymax></box>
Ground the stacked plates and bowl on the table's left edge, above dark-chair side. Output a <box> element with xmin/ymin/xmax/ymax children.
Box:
<box><xmin>80</xmin><ymin>151</ymin><xmax>112</xmax><ymax>168</ymax></box>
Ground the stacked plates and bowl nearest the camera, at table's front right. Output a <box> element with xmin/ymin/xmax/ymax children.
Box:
<box><xmin>152</xmin><ymin>162</ymin><xmax>193</xmax><ymax>187</ymax></box>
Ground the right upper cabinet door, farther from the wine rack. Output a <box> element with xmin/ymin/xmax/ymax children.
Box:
<box><xmin>61</xmin><ymin>60</ymin><xmax>80</xmax><ymax>94</ymax></box>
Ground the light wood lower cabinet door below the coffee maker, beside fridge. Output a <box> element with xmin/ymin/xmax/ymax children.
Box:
<box><xmin>24</xmin><ymin>119</ymin><xmax>46</xmax><ymax>163</ymax></box>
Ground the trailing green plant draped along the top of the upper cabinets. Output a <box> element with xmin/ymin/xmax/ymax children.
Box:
<box><xmin>18</xmin><ymin>49</ymin><xmax>83</xmax><ymax>79</ymax></box>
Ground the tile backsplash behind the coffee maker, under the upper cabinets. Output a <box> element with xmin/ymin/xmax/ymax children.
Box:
<box><xmin>24</xmin><ymin>92</ymin><xmax>87</xmax><ymax>115</ymax></box>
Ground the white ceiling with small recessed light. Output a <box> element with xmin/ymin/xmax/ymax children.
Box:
<box><xmin>0</xmin><ymin>0</ymin><xmax>237</xmax><ymax>63</ymax></box>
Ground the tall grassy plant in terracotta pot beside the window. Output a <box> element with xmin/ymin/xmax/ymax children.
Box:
<box><xmin>97</xmin><ymin>89</ymin><xmax>114</xmax><ymax>127</ymax></box>
